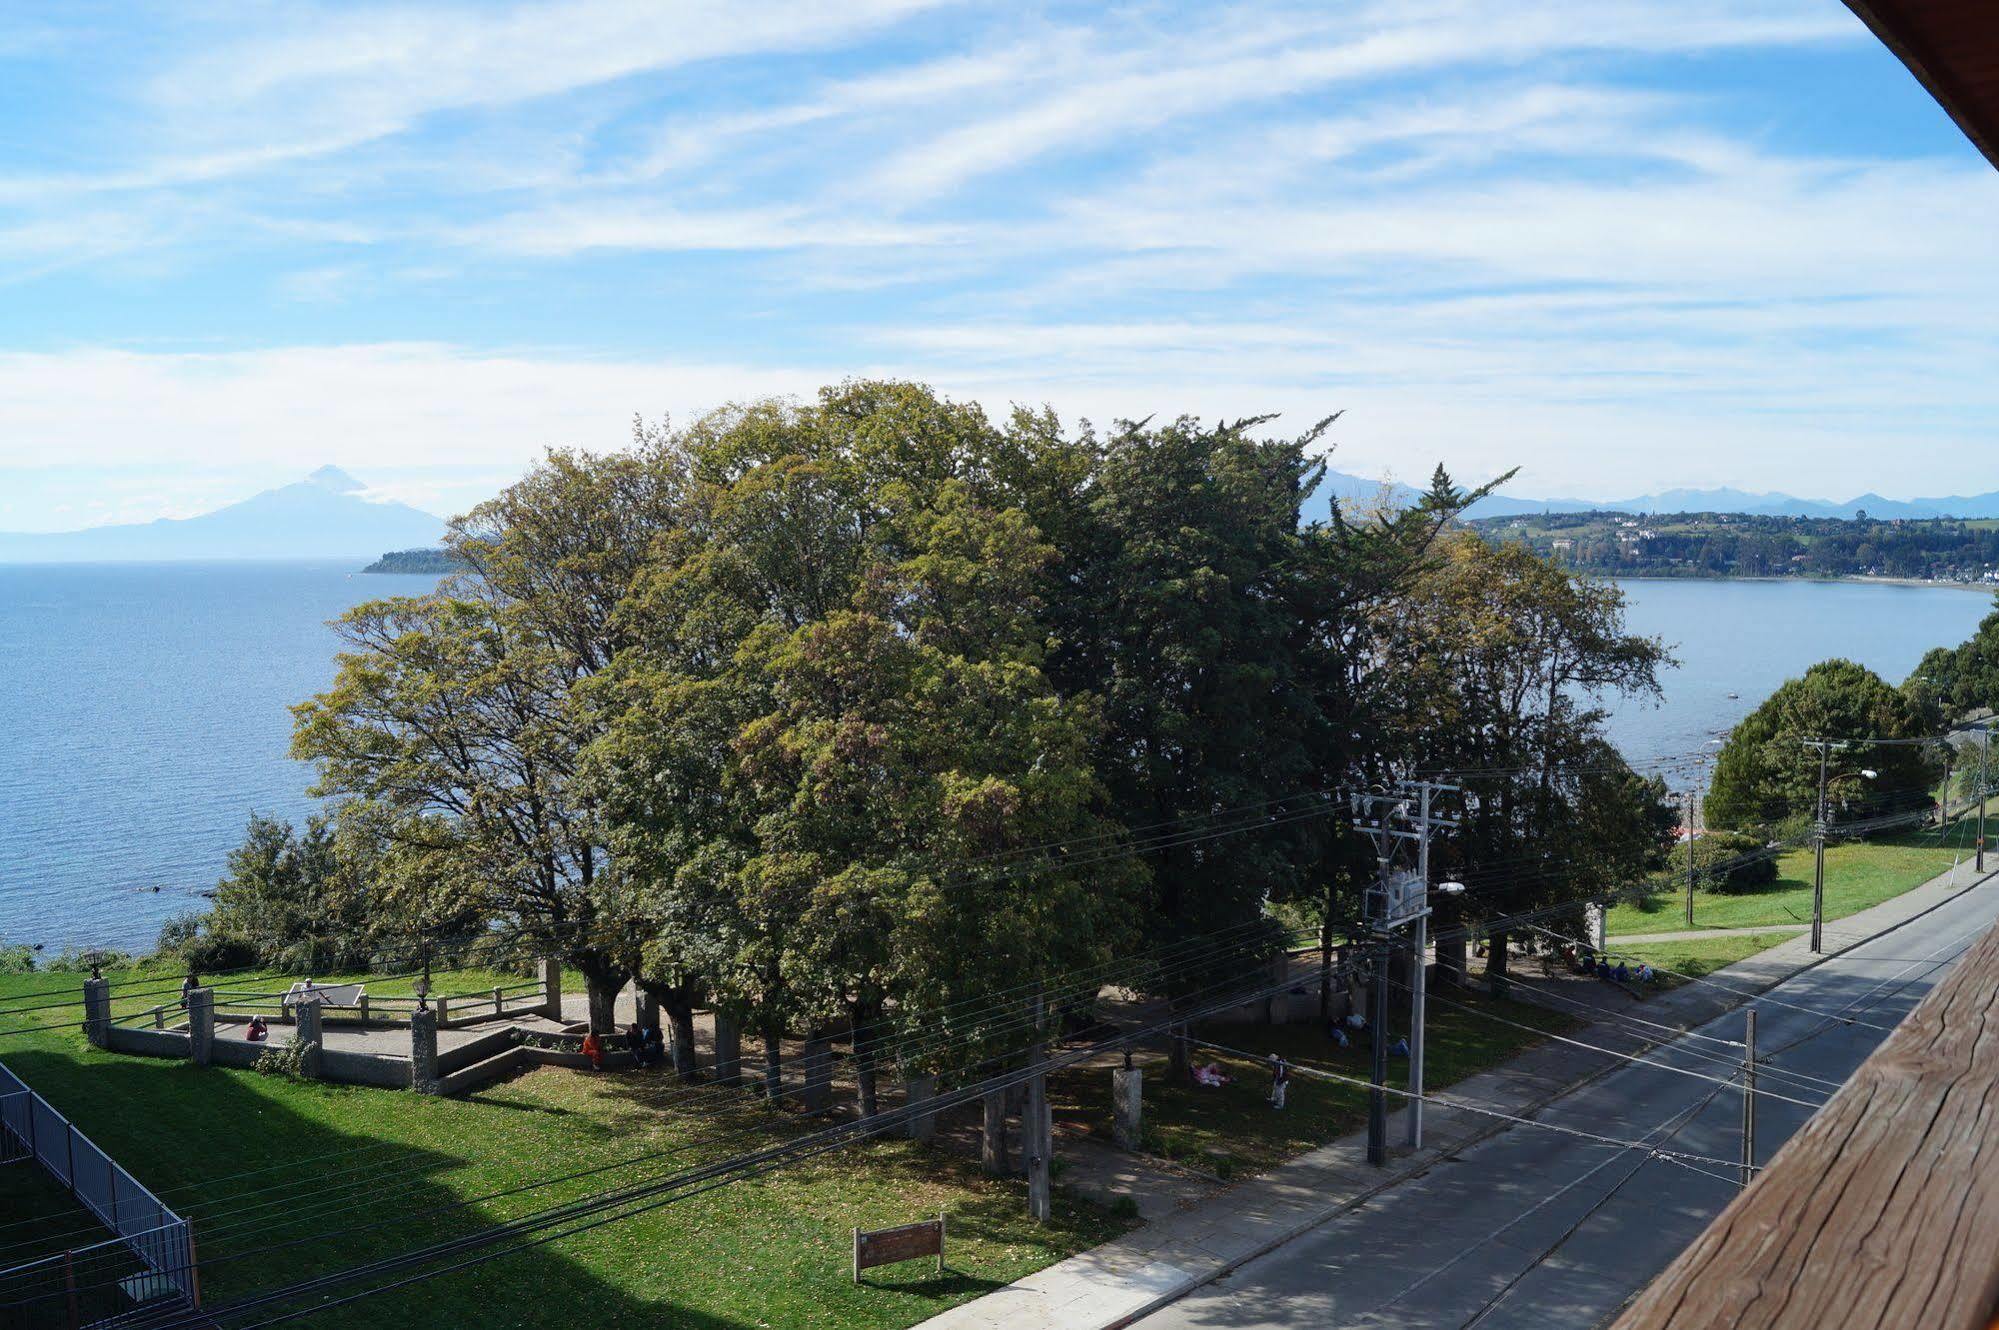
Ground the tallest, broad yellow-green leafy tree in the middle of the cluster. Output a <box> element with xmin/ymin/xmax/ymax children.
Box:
<box><xmin>592</xmin><ymin>384</ymin><xmax>1123</xmax><ymax>1096</ymax></box>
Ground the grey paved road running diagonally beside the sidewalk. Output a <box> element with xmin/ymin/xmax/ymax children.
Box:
<box><xmin>1137</xmin><ymin>884</ymin><xmax>1999</xmax><ymax>1330</ymax></box>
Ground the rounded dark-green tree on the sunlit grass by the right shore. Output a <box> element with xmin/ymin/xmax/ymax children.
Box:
<box><xmin>1703</xmin><ymin>660</ymin><xmax>1943</xmax><ymax>830</ymax></box>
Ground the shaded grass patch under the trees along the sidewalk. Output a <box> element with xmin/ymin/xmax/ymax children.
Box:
<box><xmin>1049</xmin><ymin>992</ymin><xmax>1579</xmax><ymax>1178</ymax></box>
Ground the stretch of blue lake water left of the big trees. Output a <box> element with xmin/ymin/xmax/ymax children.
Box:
<box><xmin>0</xmin><ymin>564</ymin><xmax>436</xmax><ymax>950</ymax></box>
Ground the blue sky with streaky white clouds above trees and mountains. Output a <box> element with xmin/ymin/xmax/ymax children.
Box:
<box><xmin>0</xmin><ymin>0</ymin><xmax>1999</xmax><ymax>530</ymax></box>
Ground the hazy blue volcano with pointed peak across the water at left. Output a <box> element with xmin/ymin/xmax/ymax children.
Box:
<box><xmin>0</xmin><ymin>466</ymin><xmax>444</xmax><ymax>564</ymax></box>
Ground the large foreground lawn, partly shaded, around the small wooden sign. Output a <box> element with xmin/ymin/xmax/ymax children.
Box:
<box><xmin>0</xmin><ymin>974</ymin><xmax>1127</xmax><ymax>1330</ymax></box>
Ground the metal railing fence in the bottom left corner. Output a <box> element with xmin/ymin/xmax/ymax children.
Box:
<box><xmin>0</xmin><ymin>1066</ymin><xmax>200</xmax><ymax>1324</ymax></box>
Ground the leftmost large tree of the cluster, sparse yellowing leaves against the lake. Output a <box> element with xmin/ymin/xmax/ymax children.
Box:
<box><xmin>292</xmin><ymin>430</ymin><xmax>688</xmax><ymax>1030</ymax></box>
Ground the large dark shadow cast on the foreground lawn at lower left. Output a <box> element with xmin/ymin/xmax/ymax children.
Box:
<box><xmin>6</xmin><ymin>1050</ymin><xmax>756</xmax><ymax>1330</ymax></box>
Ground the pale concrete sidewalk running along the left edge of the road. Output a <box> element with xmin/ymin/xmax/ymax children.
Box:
<box><xmin>920</xmin><ymin>860</ymin><xmax>1989</xmax><ymax>1330</ymax></box>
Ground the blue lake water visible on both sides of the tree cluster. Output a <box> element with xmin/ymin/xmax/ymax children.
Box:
<box><xmin>0</xmin><ymin>564</ymin><xmax>1989</xmax><ymax>950</ymax></box>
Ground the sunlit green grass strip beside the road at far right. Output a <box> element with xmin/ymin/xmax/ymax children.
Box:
<box><xmin>1607</xmin><ymin>822</ymin><xmax>1975</xmax><ymax>932</ymax></box>
